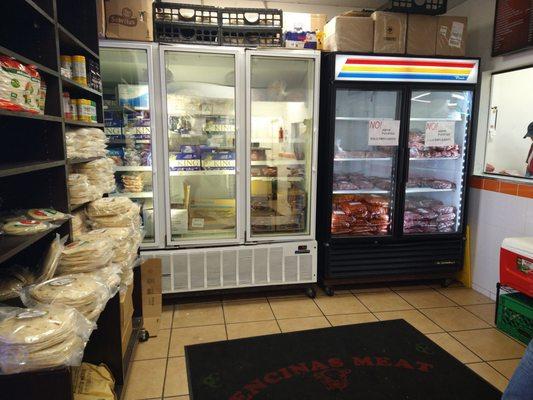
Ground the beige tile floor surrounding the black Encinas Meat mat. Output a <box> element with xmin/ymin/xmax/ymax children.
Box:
<box><xmin>125</xmin><ymin>285</ymin><xmax>525</xmax><ymax>400</ymax></box>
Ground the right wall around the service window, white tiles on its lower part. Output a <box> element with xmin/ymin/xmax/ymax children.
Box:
<box><xmin>448</xmin><ymin>0</ymin><xmax>533</xmax><ymax>298</ymax></box>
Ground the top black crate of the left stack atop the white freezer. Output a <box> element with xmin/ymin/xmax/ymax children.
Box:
<box><xmin>153</xmin><ymin>1</ymin><xmax>220</xmax><ymax>26</ymax></box>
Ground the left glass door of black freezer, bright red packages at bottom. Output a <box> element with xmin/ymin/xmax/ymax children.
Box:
<box><xmin>331</xmin><ymin>88</ymin><xmax>401</xmax><ymax>237</ymax></box>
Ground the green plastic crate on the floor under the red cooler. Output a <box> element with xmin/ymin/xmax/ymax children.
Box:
<box><xmin>497</xmin><ymin>293</ymin><xmax>533</xmax><ymax>344</ymax></box>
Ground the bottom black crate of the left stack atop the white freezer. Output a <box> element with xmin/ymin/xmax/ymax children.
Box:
<box><xmin>154</xmin><ymin>23</ymin><xmax>220</xmax><ymax>46</ymax></box>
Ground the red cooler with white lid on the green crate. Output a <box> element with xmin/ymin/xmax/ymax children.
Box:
<box><xmin>500</xmin><ymin>237</ymin><xmax>533</xmax><ymax>297</ymax></box>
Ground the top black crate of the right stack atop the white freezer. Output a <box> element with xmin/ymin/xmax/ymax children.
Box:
<box><xmin>219</xmin><ymin>7</ymin><xmax>283</xmax><ymax>29</ymax></box>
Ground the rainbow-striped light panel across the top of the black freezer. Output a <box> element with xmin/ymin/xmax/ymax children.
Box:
<box><xmin>335</xmin><ymin>54</ymin><xmax>479</xmax><ymax>83</ymax></box>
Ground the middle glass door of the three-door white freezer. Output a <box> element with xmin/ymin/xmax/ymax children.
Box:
<box><xmin>163</xmin><ymin>50</ymin><xmax>237</xmax><ymax>244</ymax></box>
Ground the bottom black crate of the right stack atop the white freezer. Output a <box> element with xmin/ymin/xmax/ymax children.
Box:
<box><xmin>220</xmin><ymin>28</ymin><xmax>283</xmax><ymax>47</ymax></box>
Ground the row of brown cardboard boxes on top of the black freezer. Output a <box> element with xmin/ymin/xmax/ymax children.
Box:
<box><xmin>324</xmin><ymin>11</ymin><xmax>467</xmax><ymax>56</ymax></box>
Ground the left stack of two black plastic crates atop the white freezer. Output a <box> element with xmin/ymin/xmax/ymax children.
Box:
<box><xmin>153</xmin><ymin>2</ymin><xmax>220</xmax><ymax>45</ymax></box>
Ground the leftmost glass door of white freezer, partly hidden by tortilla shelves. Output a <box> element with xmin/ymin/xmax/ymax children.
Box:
<box><xmin>100</xmin><ymin>47</ymin><xmax>157</xmax><ymax>244</ymax></box>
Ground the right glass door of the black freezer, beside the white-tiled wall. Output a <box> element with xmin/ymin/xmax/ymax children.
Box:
<box><xmin>403</xmin><ymin>89</ymin><xmax>473</xmax><ymax>235</ymax></box>
